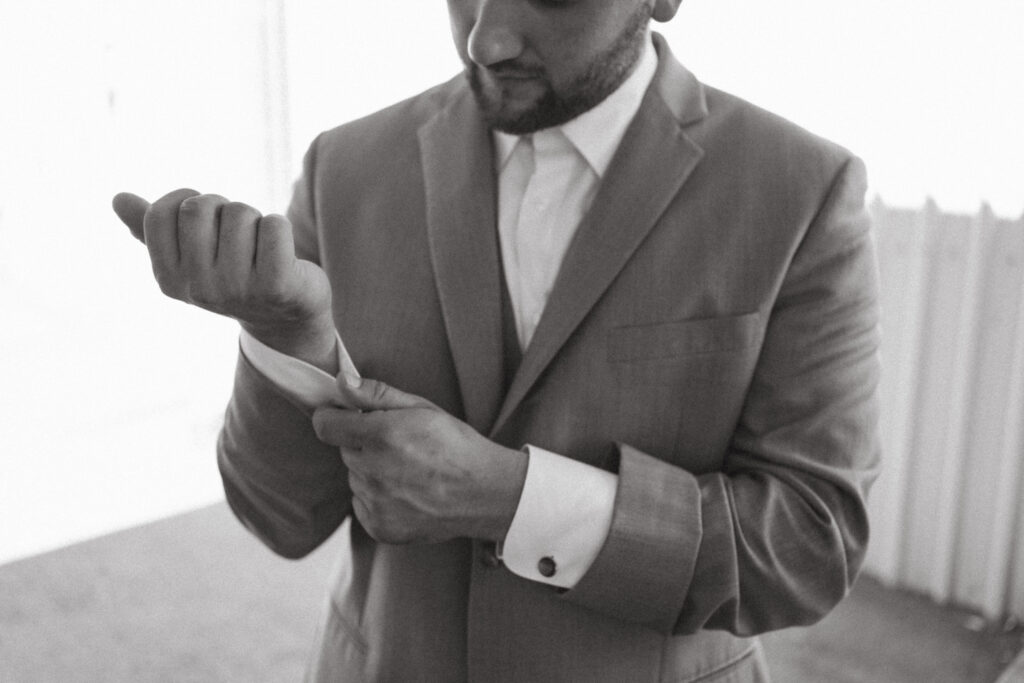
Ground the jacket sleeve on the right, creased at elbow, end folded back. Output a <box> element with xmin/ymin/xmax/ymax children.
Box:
<box><xmin>564</xmin><ymin>154</ymin><xmax>880</xmax><ymax>636</ymax></box>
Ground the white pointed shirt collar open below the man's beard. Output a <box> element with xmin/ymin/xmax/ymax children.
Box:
<box><xmin>494</xmin><ymin>32</ymin><xmax>657</xmax><ymax>177</ymax></box>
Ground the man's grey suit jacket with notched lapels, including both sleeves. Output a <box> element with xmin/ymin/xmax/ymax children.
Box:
<box><xmin>219</xmin><ymin>40</ymin><xmax>879</xmax><ymax>682</ymax></box>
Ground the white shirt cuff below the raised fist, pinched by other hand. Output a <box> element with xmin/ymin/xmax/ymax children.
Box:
<box><xmin>239</xmin><ymin>330</ymin><xmax>359</xmax><ymax>408</ymax></box>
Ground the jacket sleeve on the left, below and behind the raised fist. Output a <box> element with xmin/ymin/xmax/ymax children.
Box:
<box><xmin>217</xmin><ymin>136</ymin><xmax>351</xmax><ymax>558</ymax></box>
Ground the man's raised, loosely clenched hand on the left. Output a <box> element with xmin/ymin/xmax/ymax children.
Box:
<box><xmin>113</xmin><ymin>189</ymin><xmax>337</xmax><ymax>374</ymax></box>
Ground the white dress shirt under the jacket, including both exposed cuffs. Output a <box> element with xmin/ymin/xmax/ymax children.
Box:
<box><xmin>241</xmin><ymin>37</ymin><xmax>657</xmax><ymax>588</ymax></box>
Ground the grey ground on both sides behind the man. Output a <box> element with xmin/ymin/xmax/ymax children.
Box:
<box><xmin>0</xmin><ymin>505</ymin><xmax>1024</xmax><ymax>683</ymax></box>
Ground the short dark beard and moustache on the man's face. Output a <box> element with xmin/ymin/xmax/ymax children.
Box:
<box><xmin>466</xmin><ymin>3</ymin><xmax>651</xmax><ymax>135</ymax></box>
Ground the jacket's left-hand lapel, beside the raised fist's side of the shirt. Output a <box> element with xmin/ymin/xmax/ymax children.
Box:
<box><xmin>419</xmin><ymin>88</ymin><xmax>503</xmax><ymax>432</ymax></box>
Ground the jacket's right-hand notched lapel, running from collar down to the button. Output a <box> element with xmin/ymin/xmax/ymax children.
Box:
<box><xmin>490</xmin><ymin>45</ymin><xmax>707</xmax><ymax>434</ymax></box>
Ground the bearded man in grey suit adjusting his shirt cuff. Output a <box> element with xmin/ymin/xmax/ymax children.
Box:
<box><xmin>115</xmin><ymin>0</ymin><xmax>878</xmax><ymax>681</ymax></box>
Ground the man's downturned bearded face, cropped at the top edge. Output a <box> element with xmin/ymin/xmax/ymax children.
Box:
<box><xmin>447</xmin><ymin>0</ymin><xmax>652</xmax><ymax>134</ymax></box>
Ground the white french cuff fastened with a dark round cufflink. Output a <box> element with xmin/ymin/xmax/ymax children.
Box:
<box><xmin>501</xmin><ymin>445</ymin><xmax>618</xmax><ymax>589</ymax></box>
